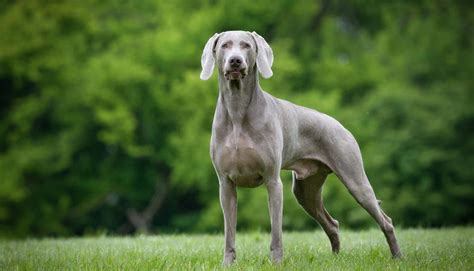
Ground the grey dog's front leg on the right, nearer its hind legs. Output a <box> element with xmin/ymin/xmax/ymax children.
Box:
<box><xmin>266</xmin><ymin>180</ymin><xmax>283</xmax><ymax>263</ymax></box>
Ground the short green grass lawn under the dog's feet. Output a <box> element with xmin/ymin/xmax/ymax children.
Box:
<box><xmin>0</xmin><ymin>227</ymin><xmax>474</xmax><ymax>270</ymax></box>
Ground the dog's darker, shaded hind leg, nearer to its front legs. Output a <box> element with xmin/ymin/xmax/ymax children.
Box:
<box><xmin>293</xmin><ymin>168</ymin><xmax>340</xmax><ymax>253</ymax></box>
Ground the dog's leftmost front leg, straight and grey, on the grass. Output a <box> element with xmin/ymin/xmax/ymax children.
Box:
<box><xmin>219</xmin><ymin>177</ymin><xmax>237</xmax><ymax>265</ymax></box>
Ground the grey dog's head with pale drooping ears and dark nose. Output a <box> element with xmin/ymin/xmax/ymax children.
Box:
<box><xmin>201</xmin><ymin>31</ymin><xmax>273</xmax><ymax>80</ymax></box>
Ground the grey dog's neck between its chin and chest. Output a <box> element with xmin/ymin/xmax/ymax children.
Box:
<box><xmin>219</xmin><ymin>68</ymin><xmax>262</xmax><ymax>131</ymax></box>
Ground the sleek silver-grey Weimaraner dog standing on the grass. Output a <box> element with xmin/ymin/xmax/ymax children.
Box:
<box><xmin>201</xmin><ymin>31</ymin><xmax>401</xmax><ymax>265</ymax></box>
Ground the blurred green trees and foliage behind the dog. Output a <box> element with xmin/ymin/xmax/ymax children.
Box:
<box><xmin>0</xmin><ymin>0</ymin><xmax>474</xmax><ymax>237</ymax></box>
